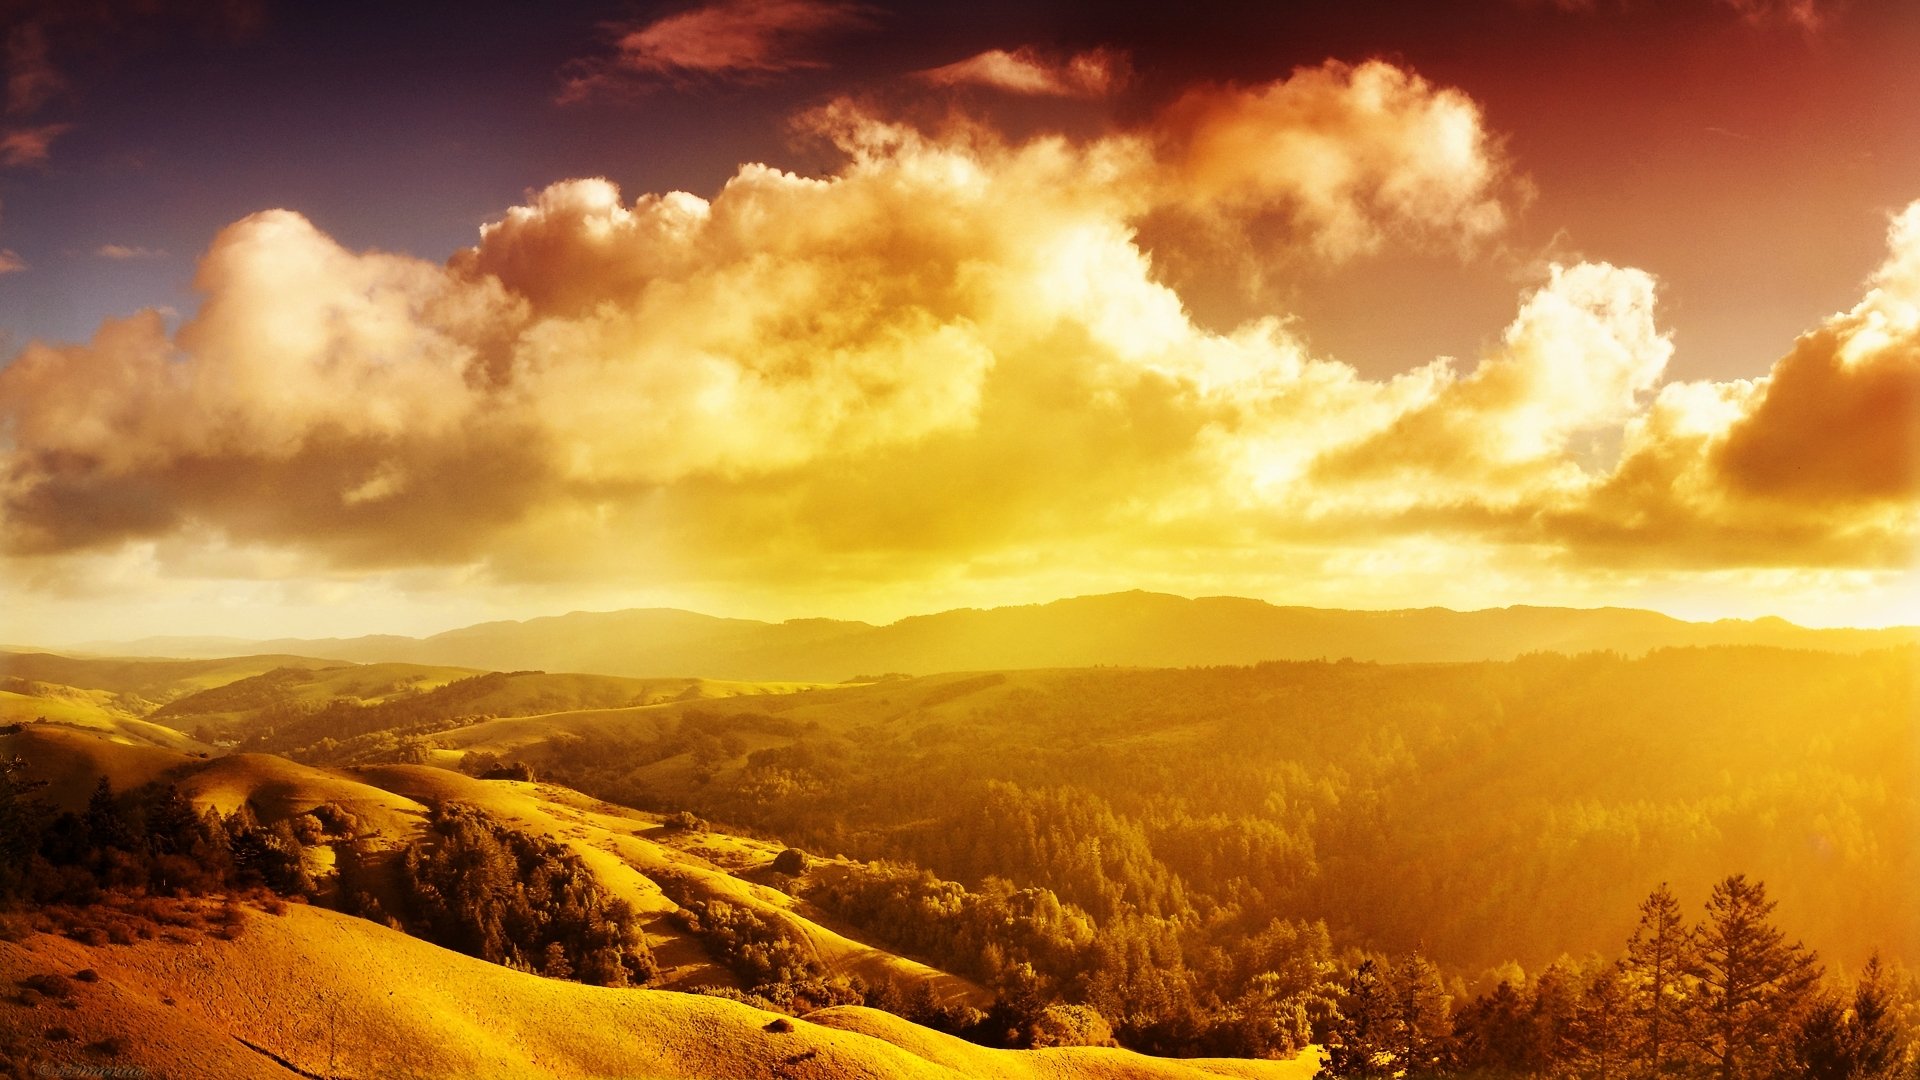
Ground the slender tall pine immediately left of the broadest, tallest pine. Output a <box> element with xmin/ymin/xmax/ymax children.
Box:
<box><xmin>1620</xmin><ymin>882</ymin><xmax>1695</xmax><ymax>1076</ymax></box>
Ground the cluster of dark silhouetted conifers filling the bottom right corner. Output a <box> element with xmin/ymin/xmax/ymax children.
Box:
<box><xmin>1323</xmin><ymin>874</ymin><xmax>1920</xmax><ymax>1080</ymax></box>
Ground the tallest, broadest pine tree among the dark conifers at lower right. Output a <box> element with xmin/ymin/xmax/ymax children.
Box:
<box><xmin>1693</xmin><ymin>874</ymin><xmax>1820</xmax><ymax>1080</ymax></box>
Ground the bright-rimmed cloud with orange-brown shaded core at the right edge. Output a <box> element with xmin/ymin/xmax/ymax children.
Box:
<box><xmin>1549</xmin><ymin>202</ymin><xmax>1920</xmax><ymax>567</ymax></box>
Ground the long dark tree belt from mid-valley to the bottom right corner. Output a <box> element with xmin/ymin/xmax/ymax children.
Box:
<box><xmin>804</xmin><ymin>845</ymin><xmax>1920</xmax><ymax>1080</ymax></box>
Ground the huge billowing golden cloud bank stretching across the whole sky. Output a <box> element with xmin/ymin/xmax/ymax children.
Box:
<box><xmin>0</xmin><ymin>63</ymin><xmax>1920</xmax><ymax>614</ymax></box>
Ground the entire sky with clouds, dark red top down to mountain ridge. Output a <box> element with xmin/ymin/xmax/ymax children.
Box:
<box><xmin>0</xmin><ymin>0</ymin><xmax>1920</xmax><ymax>644</ymax></box>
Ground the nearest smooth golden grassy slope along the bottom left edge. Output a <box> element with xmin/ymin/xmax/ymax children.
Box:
<box><xmin>0</xmin><ymin>905</ymin><xmax>1311</xmax><ymax>1080</ymax></box>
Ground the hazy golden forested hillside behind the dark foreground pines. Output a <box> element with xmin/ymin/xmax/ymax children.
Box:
<box><xmin>522</xmin><ymin>650</ymin><xmax>1920</xmax><ymax>957</ymax></box>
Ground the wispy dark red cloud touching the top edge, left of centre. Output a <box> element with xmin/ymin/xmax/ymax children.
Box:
<box><xmin>561</xmin><ymin>0</ymin><xmax>870</xmax><ymax>102</ymax></box>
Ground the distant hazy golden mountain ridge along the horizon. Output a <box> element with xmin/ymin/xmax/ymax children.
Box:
<box><xmin>67</xmin><ymin>592</ymin><xmax>1920</xmax><ymax>682</ymax></box>
